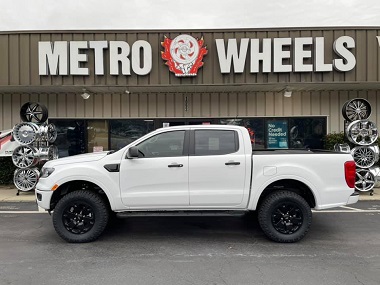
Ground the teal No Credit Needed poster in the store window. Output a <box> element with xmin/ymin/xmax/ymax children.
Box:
<box><xmin>267</xmin><ymin>120</ymin><xmax>288</xmax><ymax>148</ymax></box>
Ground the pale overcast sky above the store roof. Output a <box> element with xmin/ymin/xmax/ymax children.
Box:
<box><xmin>0</xmin><ymin>0</ymin><xmax>380</xmax><ymax>31</ymax></box>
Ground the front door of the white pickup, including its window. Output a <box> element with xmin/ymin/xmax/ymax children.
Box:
<box><xmin>120</xmin><ymin>130</ymin><xmax>189</xmax><ymax>208</ymax></box>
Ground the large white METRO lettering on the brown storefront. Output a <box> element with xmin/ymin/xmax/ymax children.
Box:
<box><xmin>38</xmin><ymin>40</ymin><xmax>152</xmax><ymax>75</ymax></box>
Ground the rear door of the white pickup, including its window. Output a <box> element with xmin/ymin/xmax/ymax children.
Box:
<box><xmin>189</xmin><ymin>129</ymin><xmax>250</xmax><ymax>207</ymax></box>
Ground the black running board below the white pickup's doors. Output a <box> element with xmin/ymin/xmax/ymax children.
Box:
<box><xmin>116</xmin><ymin>210</ymin><xmax>249</xmax><ymax>218</ymax></box>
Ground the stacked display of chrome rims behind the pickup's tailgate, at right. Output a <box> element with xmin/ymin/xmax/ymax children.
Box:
<box><xmin>334</xmin><ymin>98</ymin><xmax>380</xmax><ymax>195</ymax></box>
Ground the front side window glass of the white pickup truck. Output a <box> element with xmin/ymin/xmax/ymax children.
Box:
<box><xmin>137</xmin><ymin>131</ymin><xmax>185</xmax><ymax>158</ymax></box>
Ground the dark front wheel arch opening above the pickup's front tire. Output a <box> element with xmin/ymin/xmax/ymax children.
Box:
<box><xmin>50</xmin><ymin>180</ymin><xmax>111</xmax><ymax>210</ymax></box>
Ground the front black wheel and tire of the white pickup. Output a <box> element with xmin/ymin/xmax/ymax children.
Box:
<box><xmin>53</xmin><ymin>190</ymin><xmax>109</xmax><ymax>243</ymax></box>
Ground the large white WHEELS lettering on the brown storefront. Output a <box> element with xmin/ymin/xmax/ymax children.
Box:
<box><xmin>215</xmin><ymin>36</ymin><xmax>356</xmax><ymax>73</ymax></box>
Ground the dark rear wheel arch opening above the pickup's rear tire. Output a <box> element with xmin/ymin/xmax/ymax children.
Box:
<box><xmin>256</xmin><ymin>179</ymin><xmax>316</xmax><ymax>209</ymax></box>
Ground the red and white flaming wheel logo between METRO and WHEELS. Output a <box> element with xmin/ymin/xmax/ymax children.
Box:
<box><xmin>161</xmin><ymin>35</ymin><xmax>207</xmax><ymax>76</ymax></box>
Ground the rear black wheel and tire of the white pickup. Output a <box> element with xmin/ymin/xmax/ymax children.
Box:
<box><xmin>258</xmin><ymin>191</ymin><xmax>311</xmax><ymax>243</ymax></box>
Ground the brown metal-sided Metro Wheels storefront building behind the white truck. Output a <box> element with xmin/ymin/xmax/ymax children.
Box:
<box><xmin>0</xmin><ymin>28</ymin><xmax>380</xmax><ymax>156</ymax></box>
